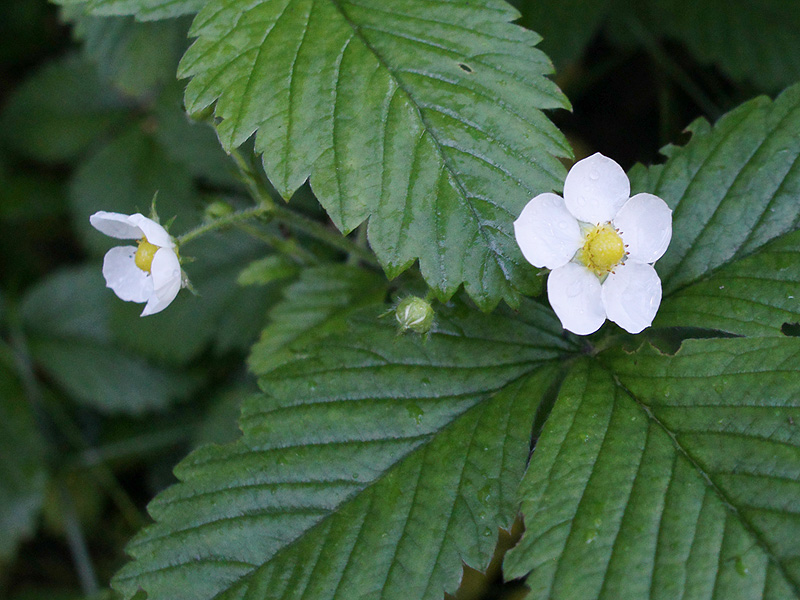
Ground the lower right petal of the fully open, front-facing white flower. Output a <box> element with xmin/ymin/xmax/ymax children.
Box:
<box><xmin>602</xmin><ymin>260</ymin><xmax>661</xmax><ymax>333</ymax></box>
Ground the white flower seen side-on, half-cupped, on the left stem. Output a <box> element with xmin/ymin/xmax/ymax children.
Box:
<box><xmin>89</xmin><ymin>211</ymin><xmax>183</xmax><ymax>317</ymax></box>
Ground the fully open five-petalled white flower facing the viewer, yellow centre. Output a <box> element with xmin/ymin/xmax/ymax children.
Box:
<box><xmin>514</xmin><ymin>153</ymin><xmax>672</xmax><ymax>335</ymax></box>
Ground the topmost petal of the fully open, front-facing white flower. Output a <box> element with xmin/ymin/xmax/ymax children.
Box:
<box><xmin>564</xmin><ymin>152</ymin><xmax>631</xmax><ymax>224</ymax></box>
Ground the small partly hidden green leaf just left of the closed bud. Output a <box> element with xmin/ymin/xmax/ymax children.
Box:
<box><xmin>249</xmin><ymin>265</ymin><xmax>386</xmax><ymax>375</ymax></box>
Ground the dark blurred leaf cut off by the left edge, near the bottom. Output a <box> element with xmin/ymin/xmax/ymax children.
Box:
<box><xmin>0</xmin><ymin>367</ymin><xmax>47</xmax><ymax>565</ymax></box>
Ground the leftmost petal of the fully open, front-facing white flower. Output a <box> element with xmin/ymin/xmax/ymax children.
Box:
<box><xmin>514</xmin><ymin>193</ymin><xmax>583</xmax><ymax>269</ymax></box>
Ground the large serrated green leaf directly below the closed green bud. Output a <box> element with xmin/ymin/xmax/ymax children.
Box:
<box><xmin>114</xmin><ymin>303</ymin><xmax>572</xmax><ymax>600</ymax></box>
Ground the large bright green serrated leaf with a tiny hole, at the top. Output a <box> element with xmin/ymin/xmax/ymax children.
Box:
<box><xmin>180</xmin><ymin>0</ymin><xmax>570</xmax><ymax>308</ymax></box>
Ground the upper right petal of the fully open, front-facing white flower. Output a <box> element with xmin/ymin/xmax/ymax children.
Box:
<box><xmin>614</xmin><ymin>194</ymin><xmax>672</xmax><ymax>263</ymax></box>
